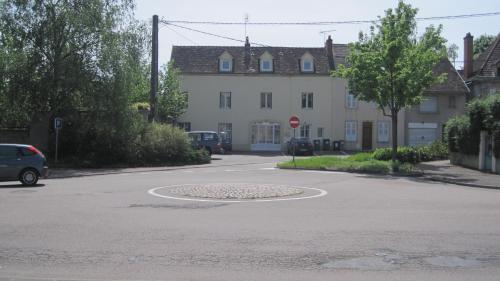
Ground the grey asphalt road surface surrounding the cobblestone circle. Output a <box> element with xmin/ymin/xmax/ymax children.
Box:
<box><xmin>0</xmin><ymin>155</ymin><xmax>500</xmax><ymax>281</ymax></box>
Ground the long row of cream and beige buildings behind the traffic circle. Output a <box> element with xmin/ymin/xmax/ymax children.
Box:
<box><xmin>171</xmin><ymin>37</ymin><xmax>468</xmax><ymax>151</ymax></box>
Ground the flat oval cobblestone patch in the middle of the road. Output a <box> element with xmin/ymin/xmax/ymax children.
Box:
<box><xmin>168</xmin><ymin>183</ymin><xmax>304</xmax><ymax>199</ymax></box>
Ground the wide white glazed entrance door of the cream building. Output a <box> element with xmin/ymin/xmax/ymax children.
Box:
<box><xmin>250</xmin><ymin>122</ymin><xmax>281</xmax><ymax>151</ymax></box>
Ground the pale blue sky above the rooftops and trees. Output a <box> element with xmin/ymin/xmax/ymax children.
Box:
<box><xmin>136</xmin><ymin>0</ymin><xmax>500</xmax><ymax>68</ymax></box>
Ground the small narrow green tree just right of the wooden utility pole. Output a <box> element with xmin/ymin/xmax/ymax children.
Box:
<box><xmin>158</xmin><ymin>62</ymin><xmax>188</xmax><ymax>123</ymax></box>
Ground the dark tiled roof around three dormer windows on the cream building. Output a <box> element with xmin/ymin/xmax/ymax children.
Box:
<box><xmin>171</xmin><ymin>44</ymin><xmax>348</xmax><ymax>75</ymax></box>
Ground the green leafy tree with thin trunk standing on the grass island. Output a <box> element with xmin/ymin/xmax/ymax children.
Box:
<box><xmin>333</xmin><ymin>1</ymin><xmax>446</xmax><ymax>164</ymax></box>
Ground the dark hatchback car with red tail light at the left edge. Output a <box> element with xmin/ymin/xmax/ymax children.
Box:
<box><xmin>0</xmin><ymin>144</ymin><xmax>48</xmax><ymax>185</ymax></box>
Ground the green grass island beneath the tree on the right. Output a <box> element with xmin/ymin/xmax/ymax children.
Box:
<box><xmin>278</xmin><ymin>153</ymin><xmax>413</xmax><ymax>174</ymax></box>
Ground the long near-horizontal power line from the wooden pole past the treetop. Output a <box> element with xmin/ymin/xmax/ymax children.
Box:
<box><xmin>162</xmin><ymin>12</ymin><xmax>500</xmax><ymax>25</ymax></box>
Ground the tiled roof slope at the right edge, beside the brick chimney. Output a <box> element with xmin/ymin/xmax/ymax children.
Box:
<box><xmin>473</xmin><ymin>34</ymin><xmax>500</xmax><ymax>77</ymax></box>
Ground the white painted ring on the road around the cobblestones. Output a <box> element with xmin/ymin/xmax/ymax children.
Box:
<box><xmin>148</xmin><ymin>184</ymin><xmax>328</xmax><ymax>203</ymax></box>
